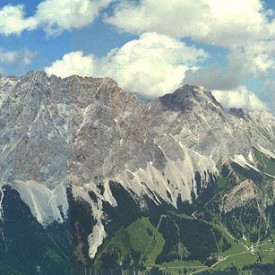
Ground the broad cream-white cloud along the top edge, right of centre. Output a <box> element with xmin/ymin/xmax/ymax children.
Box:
<box><xmin>105</xmin><ymin>0</ymin><xmax>271</xmax><ymax>47</ymax></box>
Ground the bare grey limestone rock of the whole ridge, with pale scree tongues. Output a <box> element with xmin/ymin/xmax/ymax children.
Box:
<box><xmin>0</xmin><ymin>72</ymin><xmax>275</xmax><ymax>257</ymax></box>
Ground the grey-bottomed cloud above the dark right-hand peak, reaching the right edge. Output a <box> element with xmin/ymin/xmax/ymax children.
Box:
<box><xmin>183</xmin><ymin>41</ymin><xmax>275</xmax><ymax>90</ymax></box>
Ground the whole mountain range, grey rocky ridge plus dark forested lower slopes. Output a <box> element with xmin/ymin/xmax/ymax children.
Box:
<box><xmin>0</xmin><ymin>71</ymin><xmax>275</xmax><ymax>274</ymax></box>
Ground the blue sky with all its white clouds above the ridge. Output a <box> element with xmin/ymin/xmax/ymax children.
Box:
<box><xmin>0</xmin><ymin>0</ymin><xmax>275</xmax><ymax>112</ymax></box>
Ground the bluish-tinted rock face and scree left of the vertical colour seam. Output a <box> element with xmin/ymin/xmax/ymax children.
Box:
<box><xmin>0</xmin><ymin>72</ymin><xmax>71</xmax><ymax>226</ymax></box>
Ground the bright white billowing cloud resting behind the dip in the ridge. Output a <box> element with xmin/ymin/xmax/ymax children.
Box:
<box><xmin>45</xmin><ymin>33</ymin><xmax>208</xmax><ymax>97</ymax></box>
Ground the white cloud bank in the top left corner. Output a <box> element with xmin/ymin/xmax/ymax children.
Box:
<box><xmin>0</xmin><ymin>0</ymin><xmax>112</xmax><ymax>35</ymax></box>
